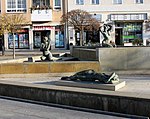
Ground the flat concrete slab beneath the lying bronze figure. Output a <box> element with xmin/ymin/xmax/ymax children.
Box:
<box><xmin>52</xmin><ymin>80</ymin><xmax>126</xmax><ymax>91</ymax></box>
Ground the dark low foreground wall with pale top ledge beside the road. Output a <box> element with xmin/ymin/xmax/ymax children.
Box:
<box><xmin>0</xmin><ymin>81</ymin><xmax>150</xmax><ymax>117</ymax></box>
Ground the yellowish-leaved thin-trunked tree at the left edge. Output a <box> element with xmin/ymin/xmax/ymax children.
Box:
<box><xmin>0</xmin><ymin>14</ymin><xmax>29</xmax><ymax>59</ymax></box>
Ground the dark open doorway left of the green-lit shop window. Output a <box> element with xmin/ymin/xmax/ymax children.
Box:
<box><xmin>115</xmin><ymin>28</ymin><xmax>123</xmax><ymax>46</ymax></box>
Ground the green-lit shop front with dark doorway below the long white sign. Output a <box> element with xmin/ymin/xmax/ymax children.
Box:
<box><xmin>115</xmin><ymin>22</ymin><xmax>143</xmax><ymax>46</ymax></box>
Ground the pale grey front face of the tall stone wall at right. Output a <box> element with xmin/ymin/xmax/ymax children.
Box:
<box><xmin>97</xmin><ymin>47</ymin><xmax>150</xmax><ymax>71</ymax></box>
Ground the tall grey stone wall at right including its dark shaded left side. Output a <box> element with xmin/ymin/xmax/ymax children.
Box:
<box><xmin>70</xmin><ymin>47</ymin><xmax>150</xmax><ymax>71</ymax></box>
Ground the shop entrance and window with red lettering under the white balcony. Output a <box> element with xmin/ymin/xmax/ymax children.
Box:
<box><xmin>33</xmin><ymin>25</ymin><xmax>65</xmax><ymax>49</ymax></box>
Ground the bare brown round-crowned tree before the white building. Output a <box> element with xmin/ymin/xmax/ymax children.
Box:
<box><xmin>61</xmin><ymin>9</ymin><xmax>100</xmax><ymax>46</ymax></box>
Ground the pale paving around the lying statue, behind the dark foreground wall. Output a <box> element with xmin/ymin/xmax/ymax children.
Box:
<box><xmin>0</xmin><ymin>73</ymin><xmax>150</xmax><ymax>94</ymax></box>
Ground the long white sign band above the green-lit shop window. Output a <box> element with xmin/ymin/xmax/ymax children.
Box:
<box><xmin>110</xmin><ymin>13</ymin><xmax>147</xmax><ymax>21</ymax></box>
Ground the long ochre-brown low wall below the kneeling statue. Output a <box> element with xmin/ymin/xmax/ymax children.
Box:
<box><xmin>0</xmin><ymin>61</ymin><xmax>100</xmax><ymax>74</ymax></box>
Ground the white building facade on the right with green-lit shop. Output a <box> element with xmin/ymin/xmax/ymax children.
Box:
<box><xmin>67</xmin><ymin>0</ymin><xmax>150</xmax><ymax>46</ymax></box>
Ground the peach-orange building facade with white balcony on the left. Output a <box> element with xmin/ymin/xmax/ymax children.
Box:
<box><xmin>0</xmin><ymin>0</ymin><xmax>66</xmax><ymax>50</ymax></box>
